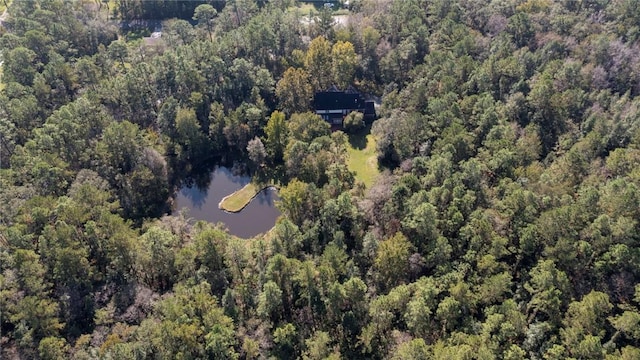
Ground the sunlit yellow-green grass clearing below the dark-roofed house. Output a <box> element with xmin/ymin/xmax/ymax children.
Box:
<box><xmin>347</xmin><ymin>125</ymin><xmax>380</xmax><ymax>188</ymax></box>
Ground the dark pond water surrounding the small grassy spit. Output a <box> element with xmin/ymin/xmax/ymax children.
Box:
<box><xmin>176</xmin><ymin>167</ymin><xmax>280</xmax><ymax>238</ymax></box>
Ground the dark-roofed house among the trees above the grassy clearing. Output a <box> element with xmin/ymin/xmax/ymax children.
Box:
<box><xmin>313</xmin><ymin>86</ymin><xmax>376</xmax><ymax>126</ymax></box>
